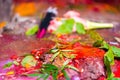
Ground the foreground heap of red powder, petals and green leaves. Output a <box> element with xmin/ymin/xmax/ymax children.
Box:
<box><xmin>0</xmin><ymin>31</ymin><xmax>120</xmax><ymax>80</ymax></box>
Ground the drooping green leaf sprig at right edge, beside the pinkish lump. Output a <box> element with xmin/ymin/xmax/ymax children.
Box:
<box><xmin>101</xmin><ymin>41</ymin><xmax>120</xmax><ymax>80</ymax></box>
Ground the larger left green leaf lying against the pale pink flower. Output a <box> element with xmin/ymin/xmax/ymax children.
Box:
<box><xmin>55</xmin><ymin>19</ymin><xmax>75</xmax><ymax>34</ymax></box>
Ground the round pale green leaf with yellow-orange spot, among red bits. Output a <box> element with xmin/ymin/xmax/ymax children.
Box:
<box><xmin>21</xmin><ymin>55</ymin><xmax>37</xmax><ymax>67</ymax></box>
